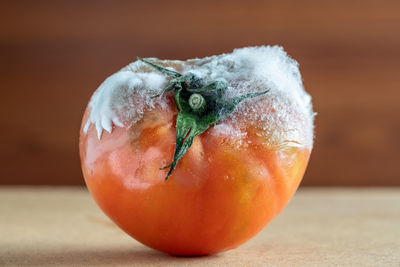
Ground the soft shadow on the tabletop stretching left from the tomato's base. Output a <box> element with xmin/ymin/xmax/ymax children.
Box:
<box><xmin>0</xmin><ymin>248</ymin><xmax>219</xmax><ymax>266</ymax></box>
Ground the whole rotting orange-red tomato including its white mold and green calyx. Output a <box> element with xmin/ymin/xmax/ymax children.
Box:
<box><xmin>80</xmin><ymin>46</ymin><xmax>313</xmax><ymax>255</ymax></box>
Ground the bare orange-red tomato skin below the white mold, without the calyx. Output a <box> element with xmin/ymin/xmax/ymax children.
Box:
<box><xmin>79</xmin><ymin>47</ymin><xmax>311</xmax><ymax>255</ymax></box>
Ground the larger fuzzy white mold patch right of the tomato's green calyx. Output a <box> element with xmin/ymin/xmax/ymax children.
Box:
<box><xmin>185</xmin><ymin>46</ymin><xmax>314</xmax><ymax>149</ymax></box>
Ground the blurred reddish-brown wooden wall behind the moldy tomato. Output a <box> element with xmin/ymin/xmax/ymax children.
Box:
<box><xmin>0</xmin><ymin>0</ymin><xmax>400</xmax><ymax>186</ymax></box>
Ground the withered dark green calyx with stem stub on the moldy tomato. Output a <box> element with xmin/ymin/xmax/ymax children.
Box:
<box><xmin>137</xmin><ymin>57</ymin><xmax>269</xmax><ymax>180</ymax></box>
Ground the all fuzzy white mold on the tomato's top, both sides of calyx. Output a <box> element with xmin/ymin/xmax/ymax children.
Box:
<box><xmin>84</xmin><ymin>46</ymin><xmax>314</xmax><ymax>149</ymax></box>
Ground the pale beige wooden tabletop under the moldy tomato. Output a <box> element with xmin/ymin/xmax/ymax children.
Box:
<box><xmin>0</xmin><ymin>187</ymin><xmax>400</xmax><ymax>266</ymax></box>
